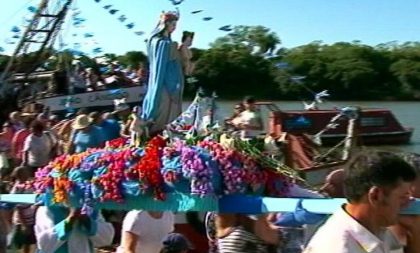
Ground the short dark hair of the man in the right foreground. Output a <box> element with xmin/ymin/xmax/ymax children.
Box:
<box><xmin>344</xmin><ymin>150</ymin><xmax>416</xmax><ymax>202</ymax></box>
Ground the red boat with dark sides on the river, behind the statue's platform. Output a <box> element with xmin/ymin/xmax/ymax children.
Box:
<box><xmin>258</xmin><ymin>102</ymin><xmax>414</xmax><ymax>146</ymax></box>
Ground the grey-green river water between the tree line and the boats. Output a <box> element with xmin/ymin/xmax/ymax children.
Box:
<box><xmin>185</xmin><ymin>101</ymin><xmax>420</xmax><ymax>153</ymax></box>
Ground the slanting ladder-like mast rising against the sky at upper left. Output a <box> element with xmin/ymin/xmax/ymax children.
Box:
<box><xmin>0</xmin><ymin>0</ymin><xmax>73</xmax><ymax>95</ymax></box>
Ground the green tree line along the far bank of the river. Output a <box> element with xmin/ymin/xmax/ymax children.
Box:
<box><xmin>0</xmin><ymin>26</ymin><xmax>420</xmax><ymax>100</ymax></box>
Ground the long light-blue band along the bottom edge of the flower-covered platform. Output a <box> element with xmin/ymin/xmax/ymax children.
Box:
<box><xmin>0</xmin><ymin>193</ymin><xmax>420</xmax><ymax>214</ymax></box>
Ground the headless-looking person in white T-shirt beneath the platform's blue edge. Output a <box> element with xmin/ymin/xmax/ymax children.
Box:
<box><xmin>117</xmin><ymin>210</ymin><xmax>175</xmax><ymax>253</ymax></box>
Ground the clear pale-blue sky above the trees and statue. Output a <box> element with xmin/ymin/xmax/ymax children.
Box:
<box><xmin>0</xmin><ymin>0</ymin><xmax>420</xmax><ymax>54</ymax></box>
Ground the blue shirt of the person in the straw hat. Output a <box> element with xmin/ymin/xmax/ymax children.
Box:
<box><xmin>73</xmin><ymin>126</ymin><xmax>105</xmax><ymax>153</ymax></box>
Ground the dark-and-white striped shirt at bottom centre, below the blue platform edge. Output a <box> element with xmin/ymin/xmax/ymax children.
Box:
<box><xmin>217</xmin><ymin>226</ymin><xmax>268</xmax><ymax>253</ymax></box>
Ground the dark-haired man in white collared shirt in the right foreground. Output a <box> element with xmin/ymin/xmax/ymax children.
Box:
<box><xmin>304</xmin><ymin>151</ymin><xmax>420</xmax><ymax>253</ymax></box>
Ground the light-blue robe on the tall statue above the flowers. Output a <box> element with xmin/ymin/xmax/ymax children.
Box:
<box><xmin>141</xmin><ymin>34</ymin><xmax>184</xmax><ymax>133</ymax></box>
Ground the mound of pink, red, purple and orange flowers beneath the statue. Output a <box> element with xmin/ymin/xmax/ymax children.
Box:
<box><xmin>34</xmin><ymin>133</ymin><xmax>292</xmax><ymax>211</ymax></box>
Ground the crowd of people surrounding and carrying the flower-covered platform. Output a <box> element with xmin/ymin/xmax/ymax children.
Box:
<box><xmin>0</xmin><ymin>97</ymin><xmax>420</xmax><ymax>253</ymax></box>
